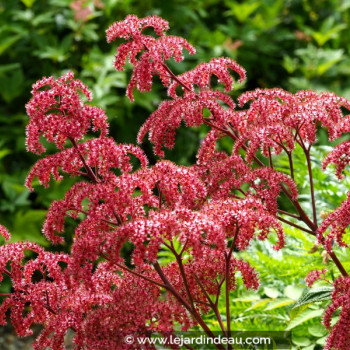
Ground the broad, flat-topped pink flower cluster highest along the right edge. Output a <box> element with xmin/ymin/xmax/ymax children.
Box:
<box><xmin>231</xmin><ymin>89</ymin><xmax>350</xmax><ymax>161</ymax></box>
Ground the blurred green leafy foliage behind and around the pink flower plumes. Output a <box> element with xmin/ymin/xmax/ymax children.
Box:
<box><xmin>0</xmin><ymin>0</ymin><xmax>350</xmax><ymax>350</ymax></box>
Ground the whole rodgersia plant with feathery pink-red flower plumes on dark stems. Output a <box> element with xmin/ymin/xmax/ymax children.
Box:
<box><xmin>0</xmin><ymin>16</ymin><xmax>350</xmax><ymax>350</ymax></box>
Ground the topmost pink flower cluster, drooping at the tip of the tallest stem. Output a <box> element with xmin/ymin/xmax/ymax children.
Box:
<box><xmin>107</xmin><ymin>15</ymin><xmax>196</xmax><ymax>101</ymax></box>
